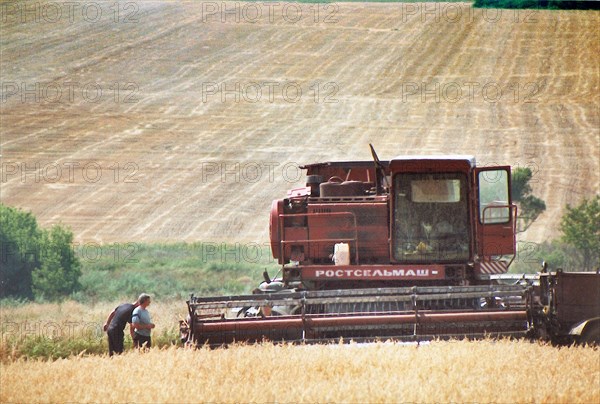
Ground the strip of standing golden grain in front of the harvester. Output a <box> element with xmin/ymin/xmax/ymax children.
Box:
<box><xmin>0</xmin><ymin>341</ymin><xmax>600</xmax><ymax>403</ymax></box>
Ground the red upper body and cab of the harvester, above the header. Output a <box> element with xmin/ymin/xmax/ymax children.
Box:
<box><xmin>270</xmin><ymin>151</ymin><xmax>516</xmax><ymax>290</ymax></box>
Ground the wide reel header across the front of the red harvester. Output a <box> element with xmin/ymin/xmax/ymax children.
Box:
<box><xmin>181</xmin><ymin>285</ymin><xmax>531</xmax><ymax>346</ymax></box>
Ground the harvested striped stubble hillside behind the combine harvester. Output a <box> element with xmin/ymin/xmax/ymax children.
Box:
<box><xmin>0</xmin><ymin>1</ymin><xmax>600</xmax><ymax>243</ymax></box>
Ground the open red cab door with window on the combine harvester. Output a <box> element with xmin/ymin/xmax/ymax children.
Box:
<box><xmin>475</xmin><ymin>166</ymin><xmax>517</xmax><ymax>259</ymax></box>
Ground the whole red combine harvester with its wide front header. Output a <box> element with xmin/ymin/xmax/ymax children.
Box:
<box><xmin>180</xmin><ymin>147</ymin><xmax>600</xmax><ymax>345</ymax></box>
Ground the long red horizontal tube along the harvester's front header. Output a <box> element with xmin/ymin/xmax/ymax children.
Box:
<box><xmin>193</xmin><ymin>311</ymin><xmax>527</xmax><ymax>345</ymax></box>
